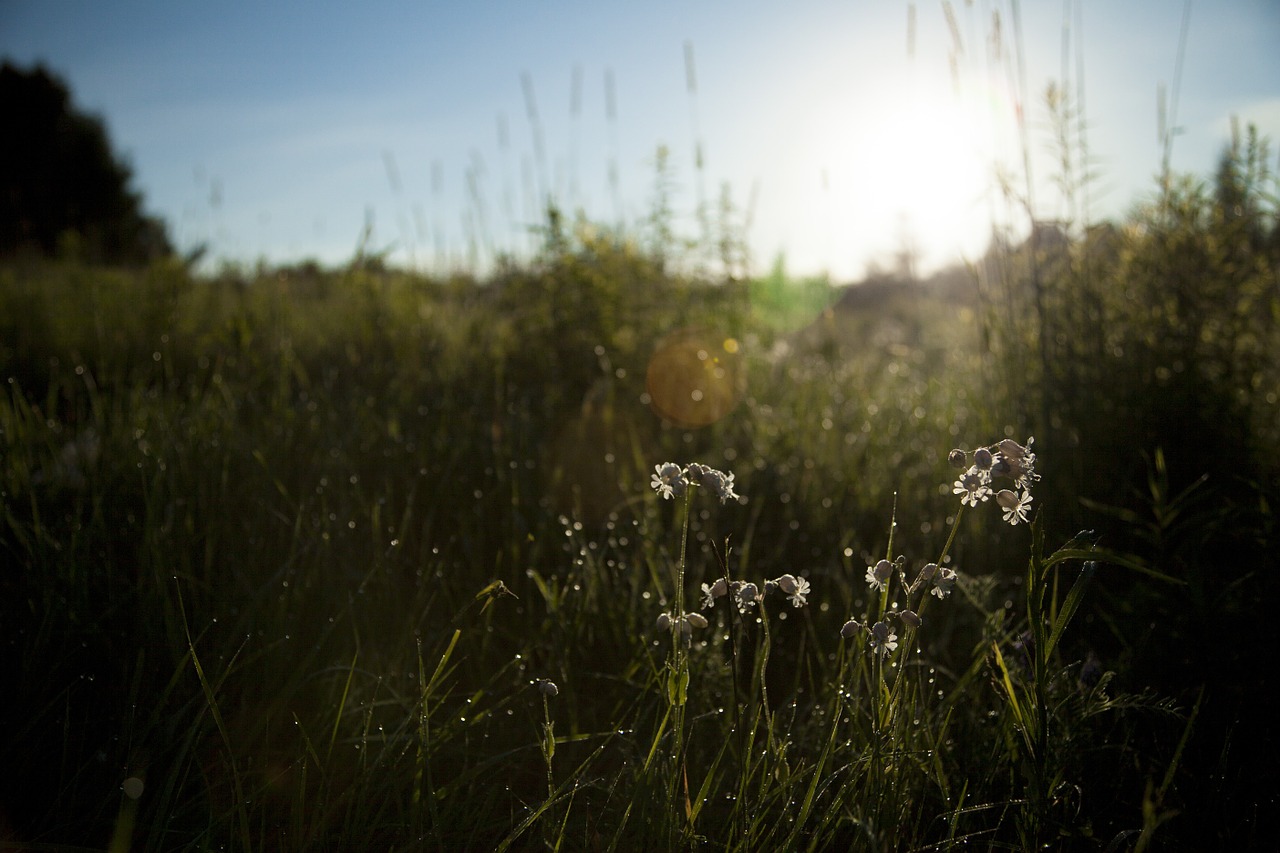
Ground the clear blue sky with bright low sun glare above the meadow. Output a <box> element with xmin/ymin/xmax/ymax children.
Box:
<box><xmin>0</xmin><ymin>0</ymin><xmax>1280</xmax><ymax>280</ymax></box>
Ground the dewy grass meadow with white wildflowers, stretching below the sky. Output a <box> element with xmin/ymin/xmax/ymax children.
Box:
<box><xmin>0</xmin><ymin>128</ymin><xmax>1280</xmax><ymax>852</ymax></box>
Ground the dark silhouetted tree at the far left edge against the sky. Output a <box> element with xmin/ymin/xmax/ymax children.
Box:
<box><xmin>0</xmin><ymin>61</ymin><xmax>173</xmax><ymax>264</ymax></box>
